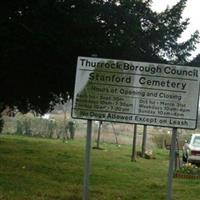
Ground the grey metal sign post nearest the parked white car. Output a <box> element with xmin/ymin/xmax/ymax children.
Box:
<box><xmin>166</xmin><ymin>128</ymin><xmax>177</xmax><ymax>200</ymax></box>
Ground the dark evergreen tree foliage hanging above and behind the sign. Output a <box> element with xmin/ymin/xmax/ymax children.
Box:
<box><xmin>0</xmin><ymin>0</ymin><xmax>198</xmax><ymax>113</ymax></box>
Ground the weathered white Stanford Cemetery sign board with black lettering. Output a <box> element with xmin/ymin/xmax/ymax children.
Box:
<box><xmin>72</xmin><ymin>57</ymin><xmax>200</xmax><ymax>129</ymax></box>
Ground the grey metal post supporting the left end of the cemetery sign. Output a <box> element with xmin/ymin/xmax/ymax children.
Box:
<box><xmin>83</xmin><ymin>120</ymin><xmax>92</xmax><ymax>200</ymax></box>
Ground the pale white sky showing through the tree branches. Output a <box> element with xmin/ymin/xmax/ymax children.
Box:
<box><xmin>152</xmin><ymin>0</ymin><xmax>200</xmax><ymax>56</ymax></box>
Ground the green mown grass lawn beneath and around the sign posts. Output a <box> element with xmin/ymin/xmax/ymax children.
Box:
<box><xmin>0</xmin><ymin>135</ymin><xmax>200</xmax><ymax>200</ymax></box>
